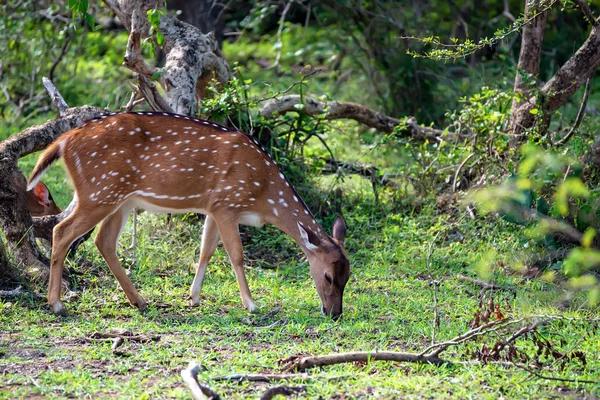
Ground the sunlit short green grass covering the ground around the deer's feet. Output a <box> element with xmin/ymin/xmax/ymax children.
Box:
<box><xmin>0</xmin><ymin>198</ymin><xmax>600</xmax><ymax>399</ymax></box>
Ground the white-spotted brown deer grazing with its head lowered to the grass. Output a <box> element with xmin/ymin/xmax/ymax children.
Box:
<box><xmin>28</xmin><ymin>112</ymin><xmax>350</xmax><ymax>317</ymax></box>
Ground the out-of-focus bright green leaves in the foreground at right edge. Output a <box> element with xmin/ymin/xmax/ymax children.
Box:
<box><xmin>471</xmin><ymin>144</ymin><xmax>600</xmax><ymax>306</ymax></box>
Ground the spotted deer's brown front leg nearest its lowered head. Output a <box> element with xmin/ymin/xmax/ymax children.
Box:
<box><xmin>216</xmin><ymin>219</ymin><xmax>257</xmax><ymax>312</ymax></box>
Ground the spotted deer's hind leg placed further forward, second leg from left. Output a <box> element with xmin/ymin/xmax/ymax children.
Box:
<box><xmin>94</xmin><ymin>203</ymin><xmax>146</xmax><ymax>310</ymax></box>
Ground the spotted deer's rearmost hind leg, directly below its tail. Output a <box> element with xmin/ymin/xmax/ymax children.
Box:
<box><xmin>48</xmin><ymin>207</ymin><xmax>114</xmax><ymax>314</ymax></box>
